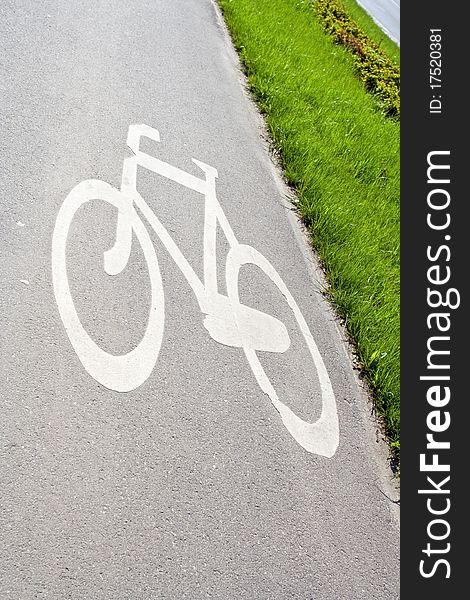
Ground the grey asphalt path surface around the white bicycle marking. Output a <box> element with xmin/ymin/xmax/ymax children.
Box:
<box><xmin>0</xmin><ymin>0</ymin><xmax>399</xmax><ymax>600</ymax></box>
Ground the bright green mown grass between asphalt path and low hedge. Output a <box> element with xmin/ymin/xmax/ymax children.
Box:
<box><xmin>218</xmin><ymin>0</ymin><xmax>400</xmax><ymax>456</ymax></box>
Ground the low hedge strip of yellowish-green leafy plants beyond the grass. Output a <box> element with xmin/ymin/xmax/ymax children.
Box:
<box><xmin>312</xmin><ymin>0</ymin><xmax>400</xmax><ymax>118</ymax></box>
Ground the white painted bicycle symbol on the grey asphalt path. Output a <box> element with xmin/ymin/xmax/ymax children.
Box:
<box><xmin>52</xmin><ymin>125</ymin><xmax>339</xmax><ymax>457</ymax></box>
